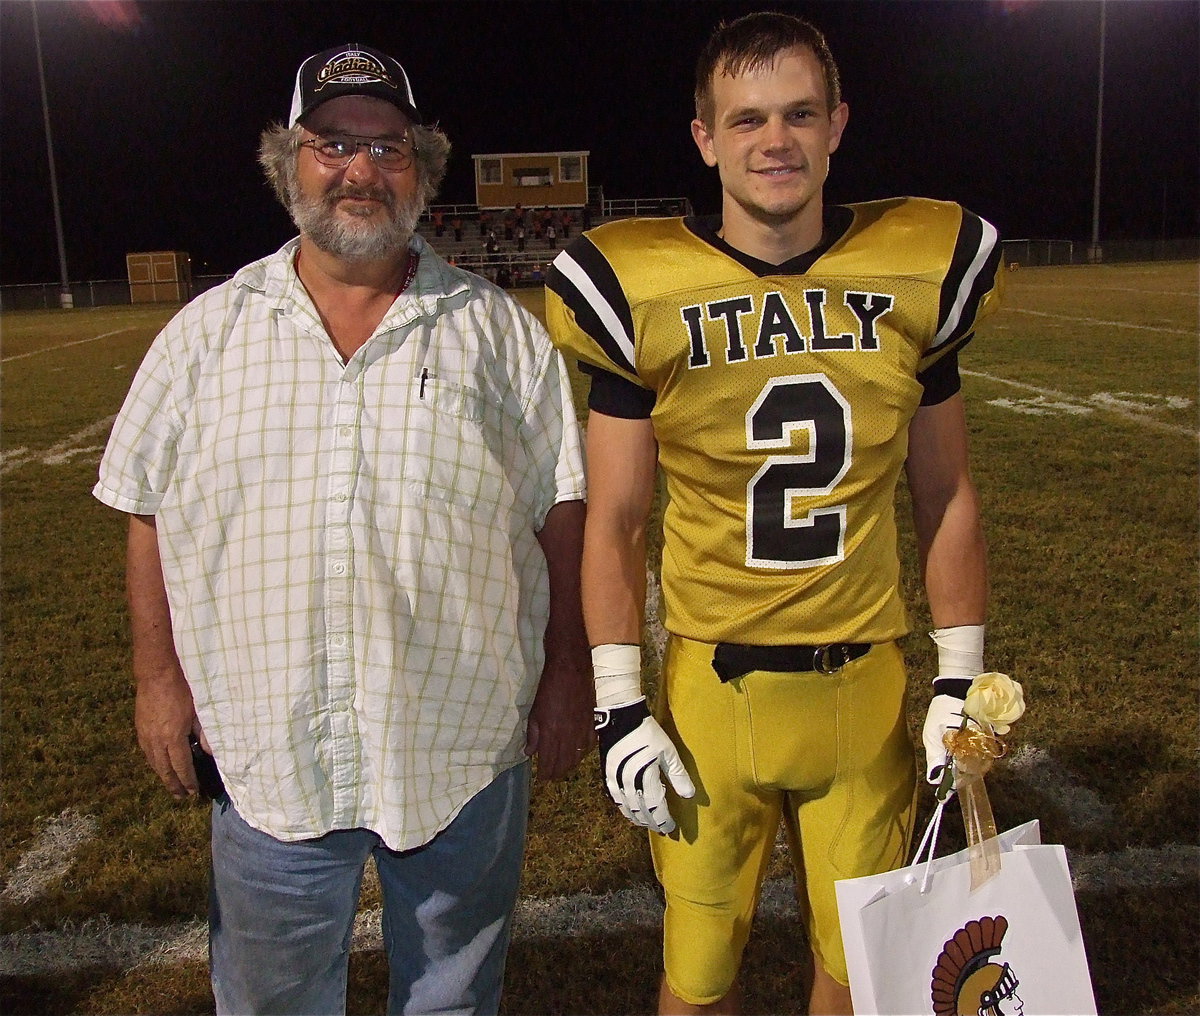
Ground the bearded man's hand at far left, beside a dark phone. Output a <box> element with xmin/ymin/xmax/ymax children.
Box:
<box><xmin>133</xmin><ymin>671</ymin><xmax>211</xmax><ymax>798</ymax></box>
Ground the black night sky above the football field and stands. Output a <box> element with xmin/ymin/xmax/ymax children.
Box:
<box><xmin>0</xmin><ymin>0</ymin><xmax>1200</xmax><ymax>283</ymax></box>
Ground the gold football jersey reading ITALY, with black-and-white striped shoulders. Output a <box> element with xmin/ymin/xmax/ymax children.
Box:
<box><xmin>546</xmin><ymin>198</ymin><xmax>1001</xmax><ymax>645</ymax></box>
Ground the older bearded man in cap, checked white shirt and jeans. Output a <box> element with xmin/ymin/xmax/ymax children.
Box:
<box><xmin>94</xmin><ymin>46</ymin><xmax>593</xmax><ymax>1014</ymax></box>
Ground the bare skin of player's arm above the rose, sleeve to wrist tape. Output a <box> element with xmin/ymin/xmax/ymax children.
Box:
<box><xmin>905</xmin><ymin>393</ymin><xmax>988</xmax><ymax>629</ymax></box>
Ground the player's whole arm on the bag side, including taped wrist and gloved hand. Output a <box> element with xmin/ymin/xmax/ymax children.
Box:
<box><xmin>905</xmin><ymin>393</ymin><xmax>988</xmax><ymax>798</ymax></box>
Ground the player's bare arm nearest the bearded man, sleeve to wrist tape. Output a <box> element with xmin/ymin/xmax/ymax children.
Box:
<box><xmin>583</xmin><ymin>410</ymin><xmax>659</xmax><ymax>645</ymax></box>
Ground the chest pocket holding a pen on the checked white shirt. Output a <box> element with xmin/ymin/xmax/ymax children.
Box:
<box><xmin>404</xmin><ymin>378</ymin><xmax>510</xmax><ymax>512</ymax></box>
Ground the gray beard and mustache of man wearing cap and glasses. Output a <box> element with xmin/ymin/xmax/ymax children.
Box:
<box><xmin>288</xmin><ymin>180</ymin><xmax>424</xmax><ymax>261</ymax></box>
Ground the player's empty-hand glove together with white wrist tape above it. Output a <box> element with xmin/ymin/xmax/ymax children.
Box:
<box><xmin>592</xmin><ymin>645</ymin><xmax>696</xmax><ymax>835</ymax></box>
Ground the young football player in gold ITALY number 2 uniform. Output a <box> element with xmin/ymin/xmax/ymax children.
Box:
<box><xmin>547</xmin><ymin>7</ymin><xmax>1001</xmax><ymax>1012</ymax></box>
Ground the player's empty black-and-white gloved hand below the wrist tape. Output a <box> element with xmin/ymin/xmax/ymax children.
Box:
<box><xmin>596</xmin><ymin>698</ymin><xmax>696</xmax><ymax>835</ymax></box>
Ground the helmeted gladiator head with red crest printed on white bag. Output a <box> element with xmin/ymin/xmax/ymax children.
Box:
<box><xmin>930</xmin><ymin>916</ymin><xmax>1025</xmax><ymax>1016</ymax></box>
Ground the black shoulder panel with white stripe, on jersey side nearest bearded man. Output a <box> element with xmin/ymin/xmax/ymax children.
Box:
<box><xmin>546</xmin><ymin>236</ymin><xmax>637</xmax><ymax>374</ymax></box>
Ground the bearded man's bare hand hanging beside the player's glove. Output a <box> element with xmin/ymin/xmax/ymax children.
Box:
<box><xmin>524</xmin><ymin>645</ymin><xmax>596</xmax><ymax>780</ymax></box>
